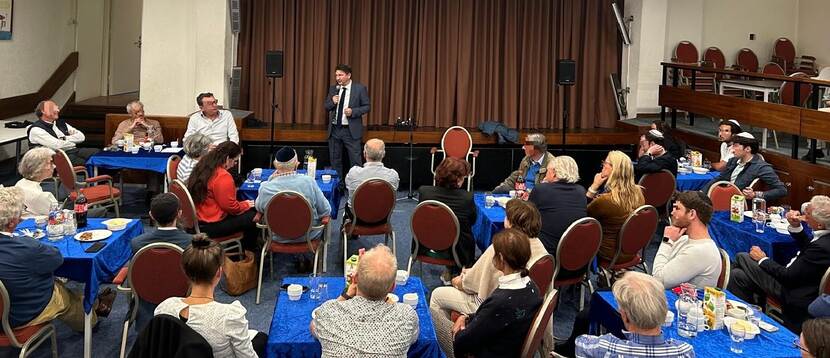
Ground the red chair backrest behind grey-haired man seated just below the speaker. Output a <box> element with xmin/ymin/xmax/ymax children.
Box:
<box><xmin>352</xmin><ymin>178</ymin><xmax>397</xmax><ymax>224</ymax></box>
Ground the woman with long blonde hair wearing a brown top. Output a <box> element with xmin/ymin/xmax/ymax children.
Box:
<box><xmin>586</xmin><ymin>150</ymin><xmax>645</xmax><ymax>262</ymax></box>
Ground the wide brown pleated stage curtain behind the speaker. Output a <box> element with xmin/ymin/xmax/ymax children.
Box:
<box><xmin>239</xmin><ymin>0</ymin><xmax>620</xmax><ymax>129</ymax></box>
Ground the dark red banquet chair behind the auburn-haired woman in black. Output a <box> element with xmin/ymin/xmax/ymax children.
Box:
<box><xmin>406</xmin><ymin>200</ymin><xmax>463</xmax><ymax>275</ymax></box>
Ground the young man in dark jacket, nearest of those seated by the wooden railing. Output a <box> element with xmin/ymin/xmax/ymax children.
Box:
<box><xmin>703</xmin><ymin>132</ymin><xmax>787</xmax><ymax>201</ymax></box>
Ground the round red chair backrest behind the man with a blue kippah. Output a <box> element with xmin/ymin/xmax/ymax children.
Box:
<box><xmin>265</xmin><ymin>190</ymin><xmax>314</xmax><ymax>239</ymax></box>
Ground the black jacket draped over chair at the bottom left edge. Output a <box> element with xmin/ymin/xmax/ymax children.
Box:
<box><xmin>128</xmin><ymin>314</ymin><xmax>213</xmax><ymax>358</ymax></box>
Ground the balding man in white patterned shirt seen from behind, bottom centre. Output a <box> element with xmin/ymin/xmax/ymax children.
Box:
<box><xmin>310</xmin><ymin>245</ymin><xmax>419</xmax><ymax>358</ymax></box>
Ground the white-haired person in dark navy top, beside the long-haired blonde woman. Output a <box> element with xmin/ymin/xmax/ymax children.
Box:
<box><xmin>528</xmin><ymin>155</ymin><xmax>588</xmax><ymax>257</ymax></box>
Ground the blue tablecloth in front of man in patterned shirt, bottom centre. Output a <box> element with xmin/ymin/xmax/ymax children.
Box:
<box><xmin>267</xmin><ymin>276</ymin><xmax>444</xmax><ymax>358</ymax></box>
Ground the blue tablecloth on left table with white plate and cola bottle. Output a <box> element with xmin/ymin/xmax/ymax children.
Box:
<box><xmin>17</xmin><ymin>218</ymin><xmax>144</xmax><ymax>313</ymax></box>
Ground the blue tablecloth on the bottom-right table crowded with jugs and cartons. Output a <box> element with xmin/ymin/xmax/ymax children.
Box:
<box><xmin>591</xmin><ymin>291</ymin><xmax>801</xmax><ymax>358</ymax></box>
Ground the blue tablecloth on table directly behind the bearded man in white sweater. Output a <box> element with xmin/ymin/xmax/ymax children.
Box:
<box><xmin>709</xmin><ymin>211</ymin><xmax>810</xmax><ymax>265</ymax></box>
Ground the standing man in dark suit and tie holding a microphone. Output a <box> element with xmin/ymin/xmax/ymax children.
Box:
<box><xmin>325</xmin><ymin>64</ymin><xmax>370</xmax><ymax>189</ymax></box>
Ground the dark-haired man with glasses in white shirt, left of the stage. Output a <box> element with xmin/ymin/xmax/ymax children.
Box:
<box><xmin>183</xmin><ymin>92</ymin><xmax>239</xmax><ymax>145</ymax></box>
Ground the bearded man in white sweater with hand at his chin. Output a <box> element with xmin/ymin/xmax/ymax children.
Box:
<box><xmin>652</xmin><ymin>191</ymin><xmax>722</xmax><ymax>288</ymax></box>
